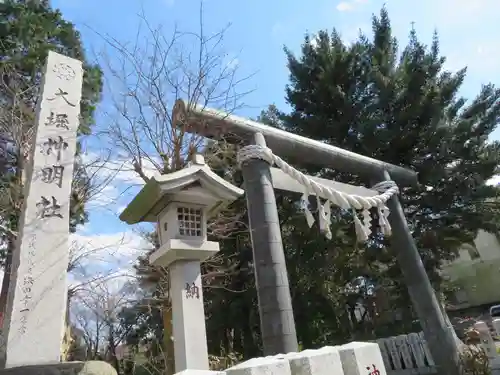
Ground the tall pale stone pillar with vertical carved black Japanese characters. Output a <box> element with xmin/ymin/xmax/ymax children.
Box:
<box><xmin>2</xmin><ymin>52</ymin><xmax>83</xmax><ymax>368</ymax></box>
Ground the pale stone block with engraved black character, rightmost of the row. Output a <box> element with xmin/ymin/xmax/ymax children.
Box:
<box><xmin>338</xmin><ymin>342</ymin><xmax>387</xmax><ymax>375</ymax></box>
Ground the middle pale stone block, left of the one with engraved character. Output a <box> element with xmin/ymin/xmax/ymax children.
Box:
<box><xmin>286</xmin><ymin>346</ymin><xmax>343</xmax><ymax>375</ymax></box>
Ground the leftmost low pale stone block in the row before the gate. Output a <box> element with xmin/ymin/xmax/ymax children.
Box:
<box><xmin>226</xmin><ymin>355</ymin><xmax>292</xmax><ymax>375</ymax></box>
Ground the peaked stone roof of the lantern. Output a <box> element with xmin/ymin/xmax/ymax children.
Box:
<box><xmin>120</xmin><ymin>154</ymin><xmax>244</xmax><ymax>224</ymax></box>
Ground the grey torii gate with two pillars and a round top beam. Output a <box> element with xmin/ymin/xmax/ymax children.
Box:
<box><xmin>172</xmin><ymin>100</ymin><xmax>459</xmax><ymax>375</ymax></box>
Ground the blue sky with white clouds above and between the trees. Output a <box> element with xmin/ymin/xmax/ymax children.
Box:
<box><xmin>47</xmin><ymin>0</ymin><xmax>500</xmax><ymax>280</ymax></box>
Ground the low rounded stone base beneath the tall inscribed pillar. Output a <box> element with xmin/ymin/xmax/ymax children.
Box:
<box><xmin>0</xmin><ymin>361</ymin><xmax>117</xmax><ymax>375</ymax></box>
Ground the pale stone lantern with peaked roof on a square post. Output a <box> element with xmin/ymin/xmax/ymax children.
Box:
<box><xmin>120</xmin><ymin>155</ymin><xmax>243</xmax><ymax>372</ymax></box>
